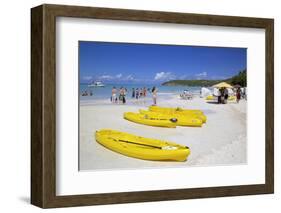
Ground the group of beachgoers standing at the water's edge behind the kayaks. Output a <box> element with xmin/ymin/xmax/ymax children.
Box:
<box><xmin>110</xmin><ymin>86</ymin><xmax>157</xmax><ymax>105</ymax></box>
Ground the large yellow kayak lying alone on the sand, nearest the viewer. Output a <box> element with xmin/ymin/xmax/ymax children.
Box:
<box><xmin>95</xmin><ymin>129</ymin><xmax>190</xmax><ymax>161</ymax></box>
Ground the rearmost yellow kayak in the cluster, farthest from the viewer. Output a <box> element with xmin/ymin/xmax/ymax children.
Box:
<box><xmin>149</xmin><ymin>106</ymin><xmax>207</xmax><ymax>123</ymax></box>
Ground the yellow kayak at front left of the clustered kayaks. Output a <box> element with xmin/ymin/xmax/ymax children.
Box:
<box><xmin>124</xmin><ymin>112</ymin><xmax>177</xmax><ymax>128</ymax></box>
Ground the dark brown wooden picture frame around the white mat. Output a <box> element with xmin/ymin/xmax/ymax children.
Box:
<box><xmin>31</xmin><ymin>5</ymin><xmax>274</xmax><ymax>208</ymax></box>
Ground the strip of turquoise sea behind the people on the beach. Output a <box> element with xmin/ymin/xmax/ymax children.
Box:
<box><xmin>79</xmin><ymin>84</ymin><xmax>201</xmax><ymax>101</ymax></box>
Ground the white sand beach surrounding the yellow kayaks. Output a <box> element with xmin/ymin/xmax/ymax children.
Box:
<box><xmin>79</xmin><ymin>96</ymin><xmax>247</xmax><ymax>171</ymax></box>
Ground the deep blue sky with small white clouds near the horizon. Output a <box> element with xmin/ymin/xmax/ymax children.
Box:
<box><xmin>79</xmin><ymin>41</ymin><xmax>247</xmax><ymax>84</ymax></box>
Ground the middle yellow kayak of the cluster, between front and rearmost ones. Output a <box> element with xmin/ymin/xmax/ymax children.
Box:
<box><xmin>139</xmin><ymin>109</ymin><xmax>202</xmax><ymax>127</ymax></box>
